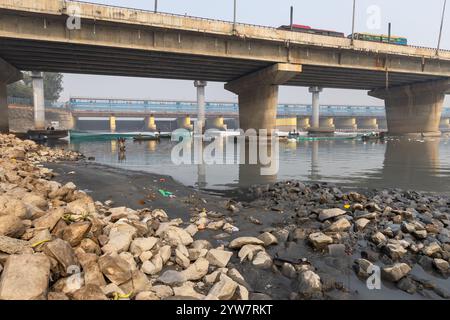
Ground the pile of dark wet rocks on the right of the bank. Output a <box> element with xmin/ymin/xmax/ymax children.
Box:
<box><xmin>250</xmin><ymin>181</ymin><xmax>450</xmax><ymax>298</ymax></box>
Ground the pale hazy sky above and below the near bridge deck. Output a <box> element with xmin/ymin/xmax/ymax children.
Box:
<box><xmin>61</xmin><ymin>0</ymin><xmax>450</xmax><ymax>105</ymax></box>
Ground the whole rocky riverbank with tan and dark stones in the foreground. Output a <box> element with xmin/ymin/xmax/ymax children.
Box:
<box><xmin>0</xmin><ymin>136</ymin><xmax>450</xmax><ymax>300</ymax></box>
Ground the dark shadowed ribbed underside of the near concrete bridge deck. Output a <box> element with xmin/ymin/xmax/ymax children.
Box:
<box><xmin>0</xmin><ymin>38</ymin><xmax>444</xmax><ymax>90</ymax></box>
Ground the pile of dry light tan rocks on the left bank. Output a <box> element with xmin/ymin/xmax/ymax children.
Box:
<box><xmin>0</xmin><ymin>136</ymin><xmax>251</xmax><ymax>300</ymax></box>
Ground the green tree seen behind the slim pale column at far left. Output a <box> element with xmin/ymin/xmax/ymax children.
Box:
<box><xmin>8</xmin><ymin>72</ymin><xmax>63</xmax><ymax>102</ymax></box>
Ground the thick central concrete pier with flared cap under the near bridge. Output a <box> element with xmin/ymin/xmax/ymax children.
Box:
<box><xmin>225</xmin><ymin>63</ymin><xmax>302</xmax><ymax>132</ymax></box>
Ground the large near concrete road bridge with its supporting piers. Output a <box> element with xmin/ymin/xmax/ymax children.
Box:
<box><xmin>0</xmin><ymin>0</ymin><xmax>450</xmax><ymax>135</ymax></box>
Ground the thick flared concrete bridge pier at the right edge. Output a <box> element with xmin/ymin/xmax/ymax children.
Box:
<box><xmin>369</xmin><ymin>79</ymin><xmax>450</xmax><ymax>136</ymax></box>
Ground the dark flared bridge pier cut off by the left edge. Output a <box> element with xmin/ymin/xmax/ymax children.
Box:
<box><xmin>0</xmin><ymin>58</ymin><xmax>22</xmax><ymax>133</ymax></box>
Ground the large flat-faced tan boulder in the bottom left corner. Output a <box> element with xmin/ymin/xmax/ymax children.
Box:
<box><xmin>0</xmin><ymin>253</ymin><xmax>50</xmax><ymax>300</ymax></box>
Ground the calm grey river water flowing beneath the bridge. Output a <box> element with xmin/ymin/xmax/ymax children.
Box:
<box><xmin>63</xmin><ymin>137</ymin><xmax>450</xmax><ymax>193</ymax></box>
